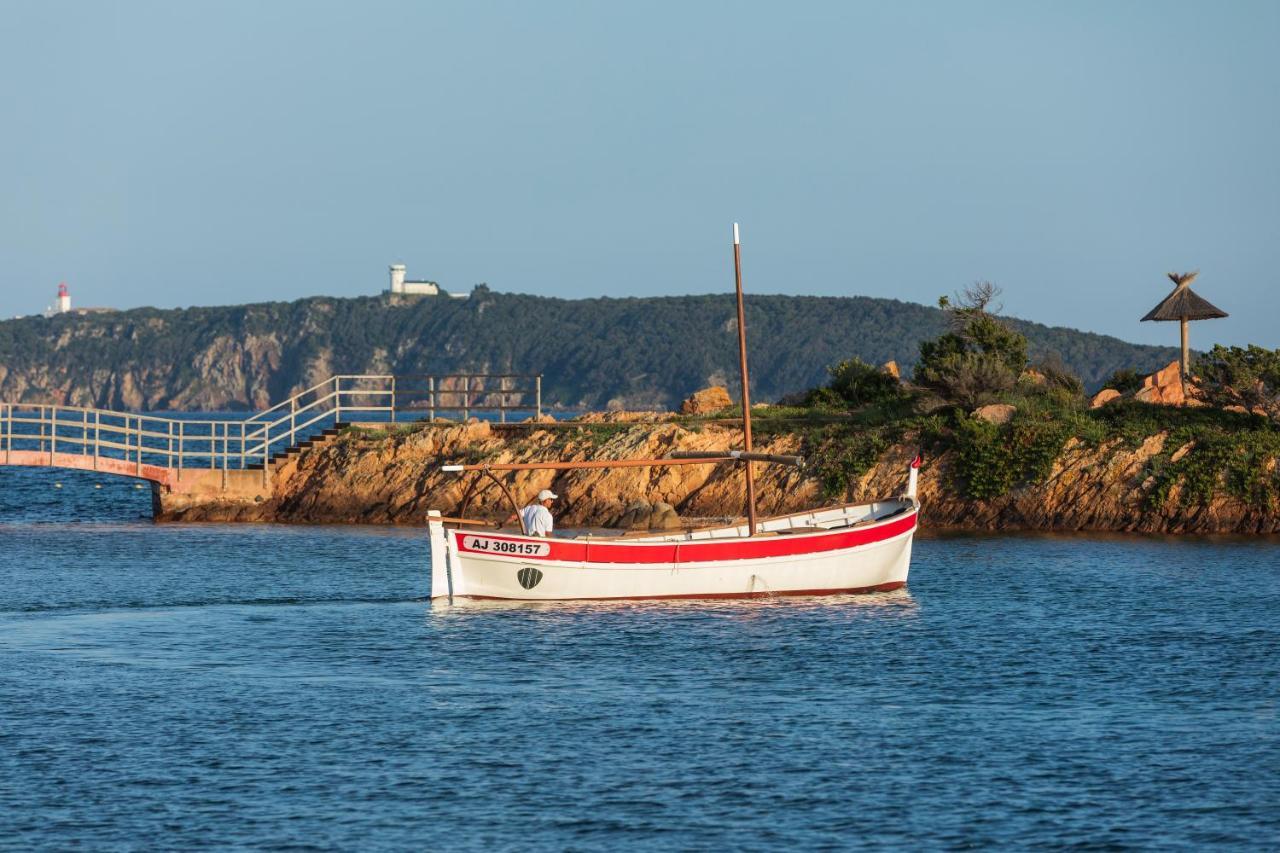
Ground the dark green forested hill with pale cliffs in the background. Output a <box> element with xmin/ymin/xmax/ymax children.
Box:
<box><xmin>0</xmin><ymin>286</ymin><xmax>1176</xmax><ymax>410</ymax></box>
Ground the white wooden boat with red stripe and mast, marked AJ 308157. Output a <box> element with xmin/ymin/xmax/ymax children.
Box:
<box><xmin>428</xmin><ymin>223</ymin><xmax>920</xmax><ymax>602</ymax></box>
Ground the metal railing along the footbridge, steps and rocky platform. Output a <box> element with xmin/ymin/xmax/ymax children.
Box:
<box><xmin>0</xmin><ymin>374</ymin><xmax>541</xmax><ymax>476</ymax></box>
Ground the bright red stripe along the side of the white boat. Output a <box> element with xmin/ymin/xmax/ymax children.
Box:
<box><xmin>452</xmin><ymin>511</ymin><xmax>916</xmax><ymax>565</ymax></box>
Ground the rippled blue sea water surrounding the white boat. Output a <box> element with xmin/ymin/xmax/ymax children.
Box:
<box><xmin>0</xmin><ymin>469</ymin><xmax>1280</xmax><ymax>849</ymax></box>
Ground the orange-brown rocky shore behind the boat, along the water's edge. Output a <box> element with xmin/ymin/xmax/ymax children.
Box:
<box><xmin>156</xmin><ymin>418</ymin><xmax>1280</xmax><ymax>534</ymax></box>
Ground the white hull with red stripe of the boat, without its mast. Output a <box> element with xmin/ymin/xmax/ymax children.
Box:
<box><xmin>431</xmin><ymin>506</ymin><xmax>916</xmax><ymax>601</ymax></box>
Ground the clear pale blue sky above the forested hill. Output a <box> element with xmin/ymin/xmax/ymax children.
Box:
<box><xmin>0</xmin><ymin>0</ymin><xmax>1280</xmax><ymax>348</ymax></box>
